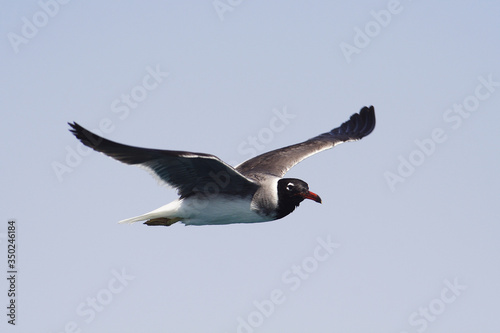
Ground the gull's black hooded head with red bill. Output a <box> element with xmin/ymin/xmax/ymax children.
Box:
<box><xmin>276</xmin><ymin>178</ymin><xmax>321</xmax><ymax>219</ymax></box>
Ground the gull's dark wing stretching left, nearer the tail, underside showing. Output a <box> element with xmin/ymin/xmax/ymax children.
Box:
<box><xmin>69</xmin><ymin>123</ymin><xmax>257</xmax><ymax>198</ymax></box>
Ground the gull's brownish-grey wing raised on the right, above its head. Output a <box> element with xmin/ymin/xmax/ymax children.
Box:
<box><xmin>236</xmin><ymin>106</ymin><xmax>375</xmax><ymax>177</ymax></box>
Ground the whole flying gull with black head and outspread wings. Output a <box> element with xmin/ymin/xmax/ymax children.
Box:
<box><xmin>68</xmin><ymin>106</ymin><xmax>375</xmax><ymax>226</ymax></box>
